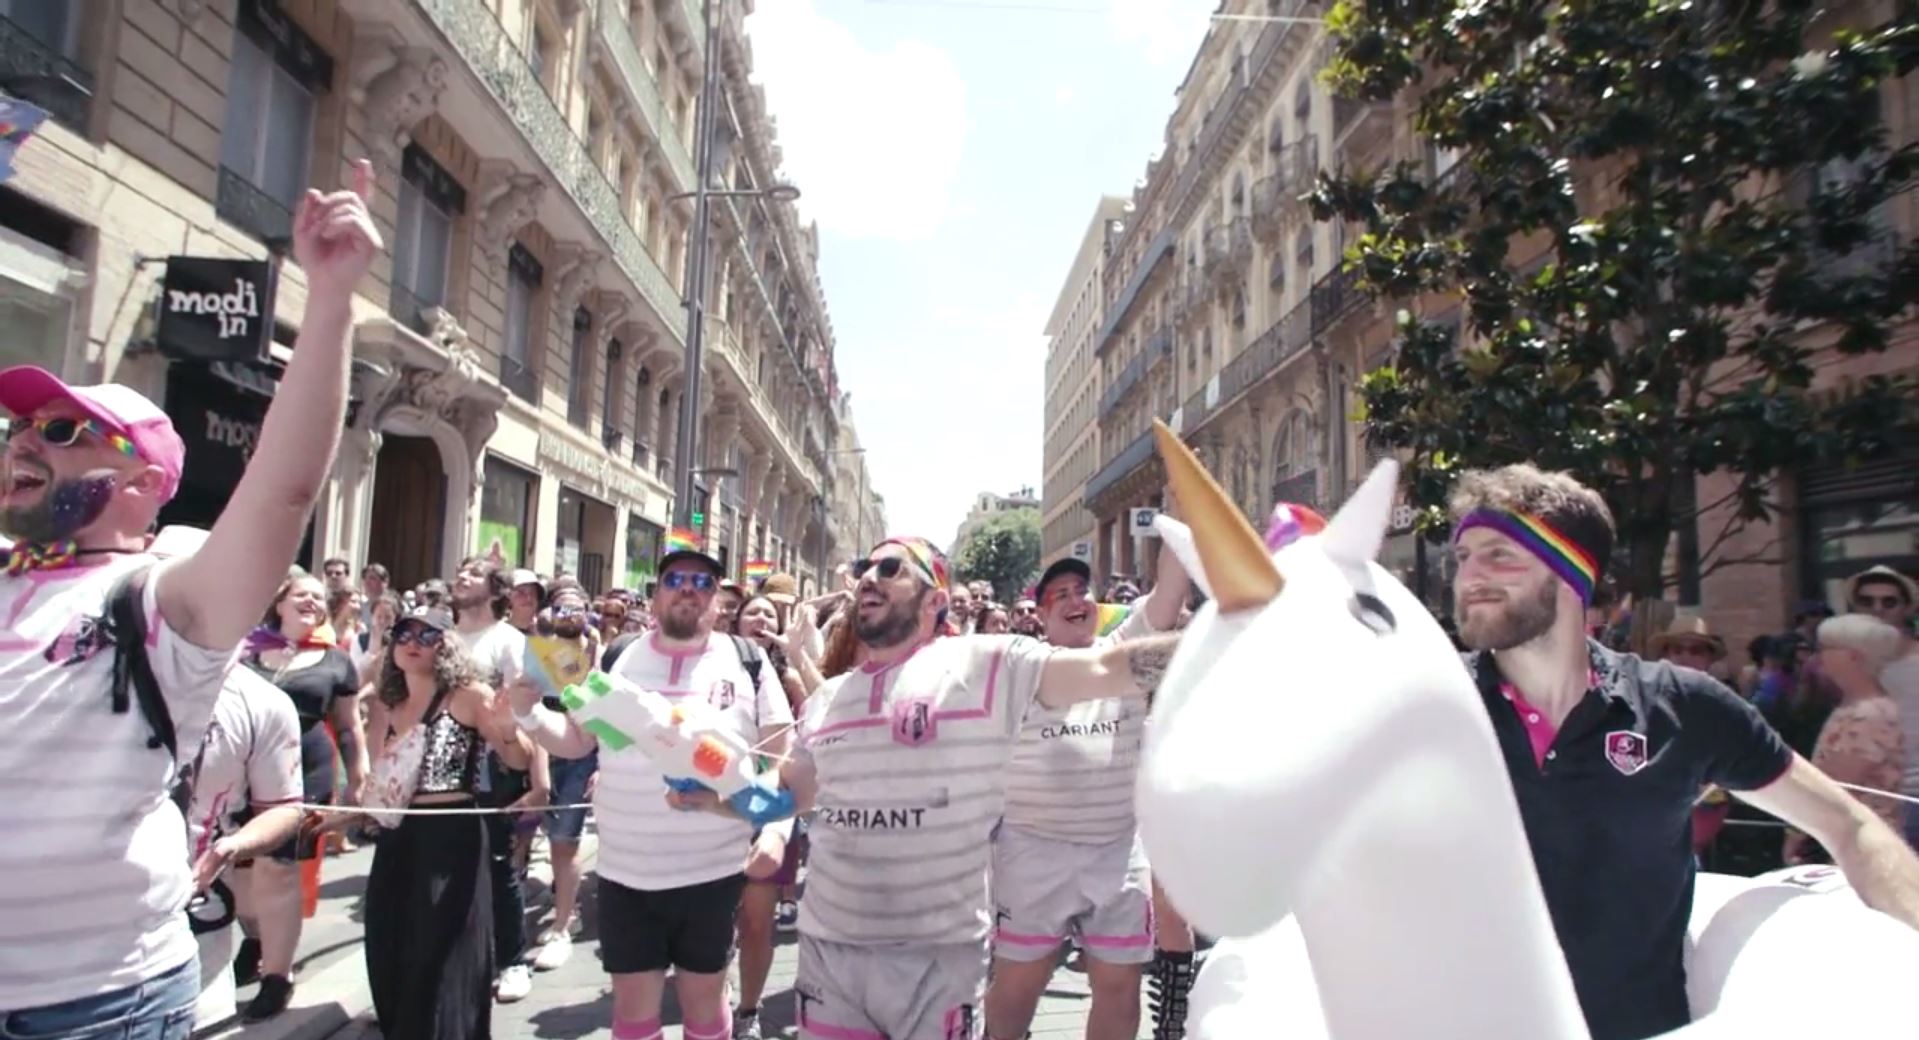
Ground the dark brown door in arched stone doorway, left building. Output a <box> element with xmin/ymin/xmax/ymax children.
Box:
<box><xmin>367</xmin><ymin>434</ymin><xmax>447</xmax><ymax>589</ymax></box>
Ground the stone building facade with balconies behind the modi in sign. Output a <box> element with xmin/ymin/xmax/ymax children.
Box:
<box><xmin>0</xmin><ymin>0</ymin><xmax>878</xmax><ymax>589</ymax></box>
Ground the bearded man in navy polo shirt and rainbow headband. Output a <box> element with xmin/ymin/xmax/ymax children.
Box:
<box><xmin>1453</xmin><ymin>466</ymin><xmax>1919</xmax><ymax>1040</ymax></box>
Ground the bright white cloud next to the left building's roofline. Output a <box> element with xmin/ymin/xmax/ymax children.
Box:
<box><xmin>746</xmin><ymin>0</ymin><xmax>965</xmax><ymax>242</ymax></box>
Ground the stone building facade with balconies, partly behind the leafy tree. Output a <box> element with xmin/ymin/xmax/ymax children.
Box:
<box><xmin>1086</xmin><ymin>0</ymin><xmax>1919</xmax><ymax>647</ymax></box>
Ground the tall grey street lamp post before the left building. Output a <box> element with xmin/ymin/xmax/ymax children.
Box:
<box><xmin>668</xmin><ymin>0</ymin><xmax>800</xmax><ymax>528</ymax></box>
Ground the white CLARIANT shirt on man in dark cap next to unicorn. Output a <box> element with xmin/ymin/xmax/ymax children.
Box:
<box><xmin>1006</xmin><ymin>610</ymin><xmax>1153</xmax><ymax>844</ymax></box>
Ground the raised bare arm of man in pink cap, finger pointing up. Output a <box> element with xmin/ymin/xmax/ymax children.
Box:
<box><xmin>155</xmin><ymin>159</ymin><xmax>384</xmax><ymax>649</ymax></box>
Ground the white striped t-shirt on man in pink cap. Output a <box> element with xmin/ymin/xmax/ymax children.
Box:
<box><xmin>0</xmin><ymin>555</ymin><xmax>236</xmax><ymax>1009</ymax></box>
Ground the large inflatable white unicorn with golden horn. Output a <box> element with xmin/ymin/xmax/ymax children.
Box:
<box><xmin>1138</xmin><ymin>426</ymin><xmax>1919</xmax><ymax>1040</ymax></box>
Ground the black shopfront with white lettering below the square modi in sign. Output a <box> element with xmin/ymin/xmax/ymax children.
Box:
<box><xmin>159</xmin><ymin>361</ymin><xmax>313</xmax><ymax>570</ymax></box>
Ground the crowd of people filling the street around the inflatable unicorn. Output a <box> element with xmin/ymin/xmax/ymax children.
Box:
<box><xmin>0</xmin><ymin>155</ymin><xmax>1919</xmax><ymax>1040</ymax></box>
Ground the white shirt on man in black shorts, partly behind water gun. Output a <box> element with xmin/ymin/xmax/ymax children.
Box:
<box><xmin>593</xmin><ymin>633</ymin><xmax>793</xmax><ymax>892</ymax></box>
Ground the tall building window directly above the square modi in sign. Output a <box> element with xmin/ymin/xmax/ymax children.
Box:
<box><xmin>215</xmin><ymin>0</ymin><xmax>334</xmax><ymax>246</ymax></box>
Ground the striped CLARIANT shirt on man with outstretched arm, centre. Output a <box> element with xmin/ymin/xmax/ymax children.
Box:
<box><xmin>796</xmin><ymin>635</ymin><xmax>1052</xmax><ymax>946</ymax></box>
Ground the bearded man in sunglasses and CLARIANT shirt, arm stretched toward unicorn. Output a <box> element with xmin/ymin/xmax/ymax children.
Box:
<box><xmin>675</xmin><ymin>537</ymin><xmax>1178</xmax><ymax>1040</ymax></box>
